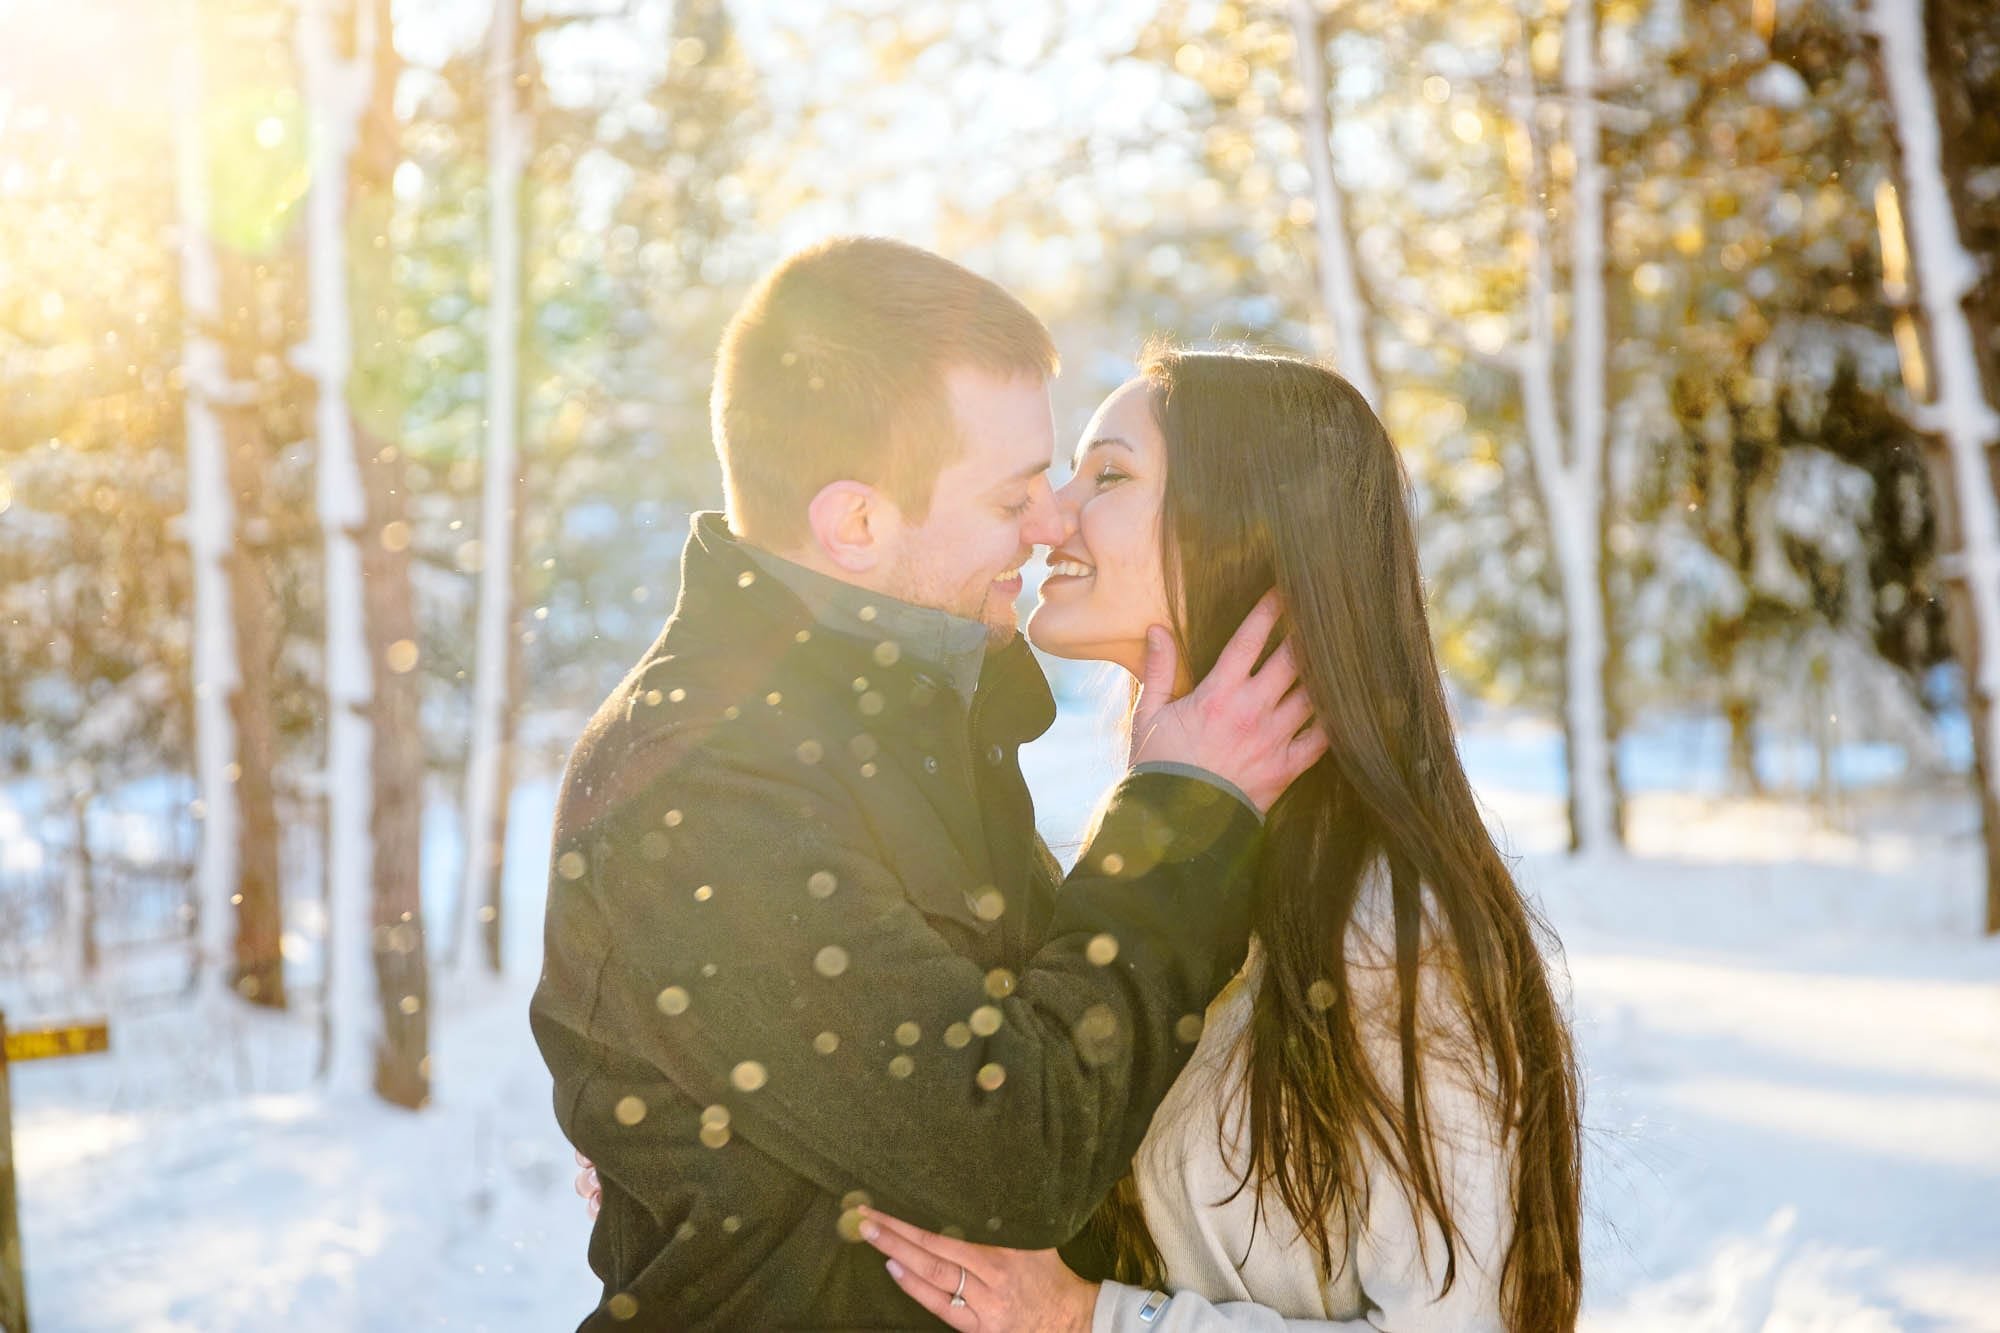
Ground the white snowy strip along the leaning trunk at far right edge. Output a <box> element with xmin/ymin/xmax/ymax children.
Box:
<box><xmin>1868</xmin><ymin>0</ymin><xmax>2000</xmax><ymax>915</ymax></box>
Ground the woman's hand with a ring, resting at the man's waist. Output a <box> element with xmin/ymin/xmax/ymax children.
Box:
<box><xmin>862</xmin><ymin>1209</ymin><xmax>1098</xmax><ymax>1333</ymax></box>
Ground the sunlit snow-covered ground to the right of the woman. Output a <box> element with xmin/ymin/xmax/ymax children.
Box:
<box><xmin>1524</xmin><ymin>799</ymin><xmax>2000</xmax><ymax>1333</ymax></box>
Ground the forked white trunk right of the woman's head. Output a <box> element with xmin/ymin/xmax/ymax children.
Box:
<box><xmin>1512</xmin><ymin>0</ymin><xmax>1618</xmax><ymax>855</ymax></box>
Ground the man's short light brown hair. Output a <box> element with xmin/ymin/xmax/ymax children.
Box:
<box><xmin>710</xmin><ymin>236</ymin><xmax>1058</xmax><ymax>548</ymax></box>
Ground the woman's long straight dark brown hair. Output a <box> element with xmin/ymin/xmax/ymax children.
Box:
<box><xmin>1094</xmin><ymin>350</ymin><xmax>1582</xmax><ymax>1333</ymax></box>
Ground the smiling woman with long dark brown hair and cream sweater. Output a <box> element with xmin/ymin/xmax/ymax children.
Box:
<box><xmin>864</xmin><ymin>352</ymin><xmax>1582</xmax><ymax>1333</ymax></box>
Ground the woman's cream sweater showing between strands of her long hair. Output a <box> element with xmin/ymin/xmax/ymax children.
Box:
<box><xmin>1092</xmin><ymin>869</ymin><xmax>1512</xmax><ymax>1333</ymax></box>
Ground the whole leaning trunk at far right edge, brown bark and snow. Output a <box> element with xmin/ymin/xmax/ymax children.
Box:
<box><xmin>1868</xmin><ymin>0</ymin><xmax>2000</xmax><ymax>935</ymax></box>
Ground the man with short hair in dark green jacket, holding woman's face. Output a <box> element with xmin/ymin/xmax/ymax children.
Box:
<box><xmin>530</xmin><ymin>238</ymin><xmax>1322</xmax><ymax>1329</ymax></box>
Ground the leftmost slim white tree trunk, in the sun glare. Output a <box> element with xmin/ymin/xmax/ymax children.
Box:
<box><xmin>174</xmin><ymin>13</ymin><xmax>242</xmax><ymax>1003</ymax></box>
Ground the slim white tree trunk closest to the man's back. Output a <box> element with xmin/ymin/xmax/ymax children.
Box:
<box><xmin>452</xmin><ymin>0</ymin><xmax>528</xmax><ymax>975</ymax></box>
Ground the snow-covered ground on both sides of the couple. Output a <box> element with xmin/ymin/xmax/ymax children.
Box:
<box><xmin>0</xmin><ymin>709</ymin><xmax>2000</xmax><ymax>1333</ymax></box>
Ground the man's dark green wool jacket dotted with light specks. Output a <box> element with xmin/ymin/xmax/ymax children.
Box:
<box><xmin>530</xmin><ymin>514</ymin><xmax>1258</xmax><ymax>1329</ymax></box>
